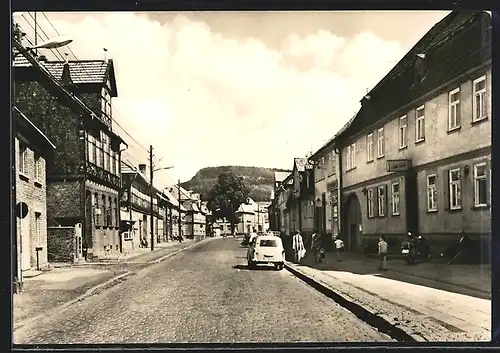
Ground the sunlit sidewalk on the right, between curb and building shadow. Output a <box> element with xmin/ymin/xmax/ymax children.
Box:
<box><xmin>288</xmin><ymin>254</ymin><xmax>491</xmax><ymax>341</ymax></box>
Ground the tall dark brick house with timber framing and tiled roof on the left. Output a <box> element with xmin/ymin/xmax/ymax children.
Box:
<box><xmin>14</xmin><ymin>43</ymin><xmax>125</xmax><ymax>261</ymax></box>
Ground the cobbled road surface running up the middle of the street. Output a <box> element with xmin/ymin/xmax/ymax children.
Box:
<box><xmin>14</xmin><ymin>237</ymin><xmax>390</xmax><ymax>344</ymax></box>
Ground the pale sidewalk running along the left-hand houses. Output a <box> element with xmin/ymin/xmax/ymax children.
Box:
<box><xmin>14</xmin><ymin>238</ymin><xmax>206</xmax><ymax>326</ymax></box>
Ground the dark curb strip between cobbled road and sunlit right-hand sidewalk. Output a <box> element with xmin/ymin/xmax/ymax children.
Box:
<box><xmin>284</xmin><ymin>263</ymin><xmax>420</xmax><ymax>342</ymax></box>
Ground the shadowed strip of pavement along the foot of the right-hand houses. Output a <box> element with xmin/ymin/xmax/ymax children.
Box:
<box><xmin>304</xmin><ymin>252</ymin><xmax>491</xmax><ymax>299</ymax></box>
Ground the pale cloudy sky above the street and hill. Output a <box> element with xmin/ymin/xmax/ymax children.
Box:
<box><xmin>14</xmin><ymin>11</ymin><xmax>448</xmax><ymax>185</ymax></box>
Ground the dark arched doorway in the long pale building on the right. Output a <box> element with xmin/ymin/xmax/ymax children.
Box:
<box><xmin>342</xmin><ymin>193</ymin><xmax>361</xmax><ymax>251</ymax></box>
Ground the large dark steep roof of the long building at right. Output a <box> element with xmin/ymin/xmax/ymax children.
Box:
<box><xmin>338</xmin><ymin>11</ymin><xmax>491</xmax><ymax>143</ymax></box>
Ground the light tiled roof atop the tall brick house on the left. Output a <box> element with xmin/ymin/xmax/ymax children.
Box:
<box><xmin>14</xmin><ymin>55</ymin><xmax>118</xmax><ymax>97</ymax></box>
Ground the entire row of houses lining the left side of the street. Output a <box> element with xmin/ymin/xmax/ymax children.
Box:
<box><xmin>12</xmin><ymin>28</ymin><xmax>210</xmax><ymax>292</ymax></box>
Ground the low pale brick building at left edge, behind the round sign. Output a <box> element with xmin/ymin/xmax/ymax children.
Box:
<box><xmin>13</xmin><ymin>107</ymin><xmax>55</xmax><ymax>283</ymax></box>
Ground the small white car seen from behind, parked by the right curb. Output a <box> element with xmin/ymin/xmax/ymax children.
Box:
<box><xmin>247</xmin><ymin>235</ymin><xmax>285</xmax><ymax>270</ymax></box>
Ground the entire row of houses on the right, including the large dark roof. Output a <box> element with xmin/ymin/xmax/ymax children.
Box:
<box><xmin>269</xmin><ymin>11</ymin><xmax>493</xmax><ymax>258</ymax></box>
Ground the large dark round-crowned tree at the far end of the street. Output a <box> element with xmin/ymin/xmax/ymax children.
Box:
<box><xmin>208</xmin><ymin>171</ymin><xmax>251</xmax><ymax>232</ymax></box>
